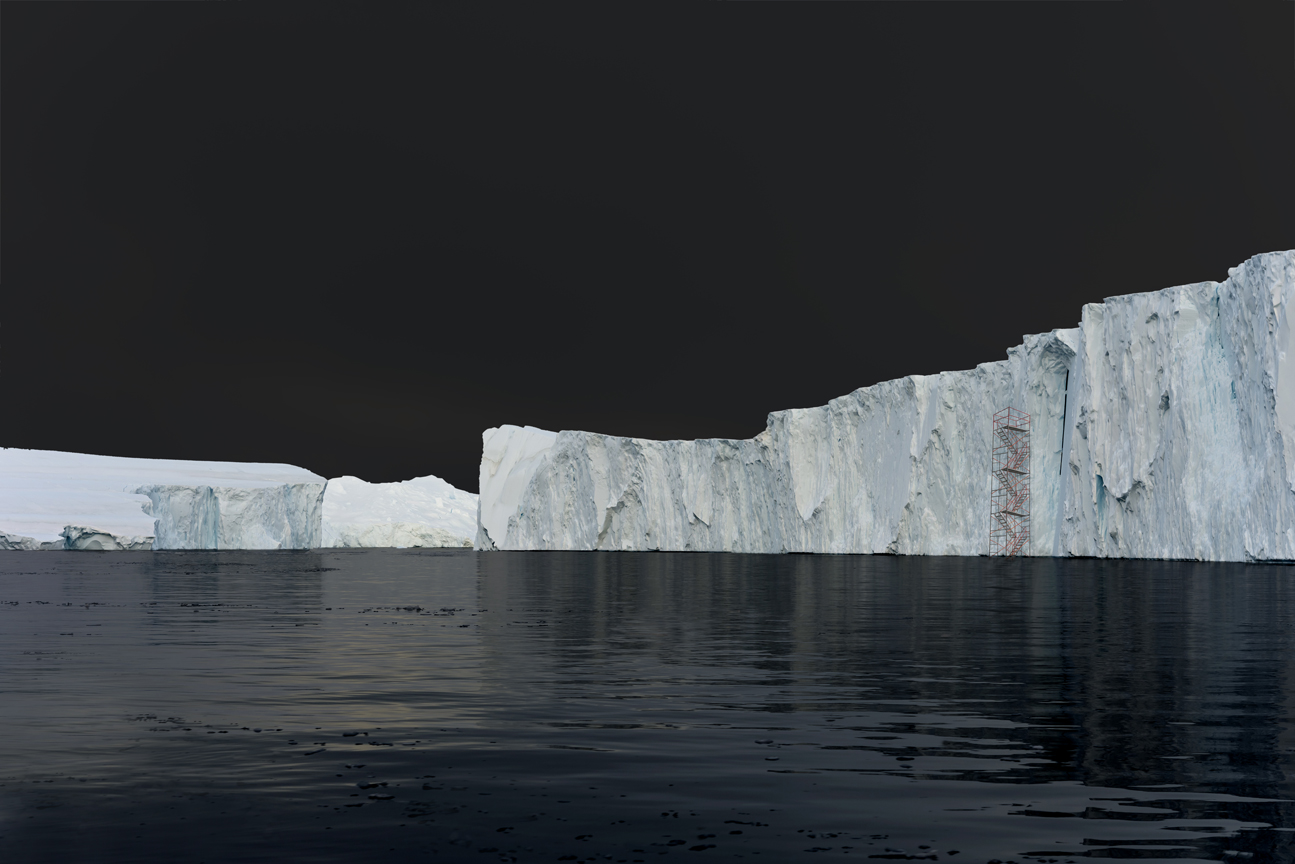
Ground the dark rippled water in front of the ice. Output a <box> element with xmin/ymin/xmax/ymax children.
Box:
<box><xmin>0</xmin><ymin>551</ymin><xmax>1295</xmax><ymax>864</ymax></box>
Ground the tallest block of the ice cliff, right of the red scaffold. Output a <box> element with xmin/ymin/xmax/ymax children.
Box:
<box><xmin>1059</xmin><ymin>253</ymin><xmax>1295</xmax><ymax>561</ymax></box>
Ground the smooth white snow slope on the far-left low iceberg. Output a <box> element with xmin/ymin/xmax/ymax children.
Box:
<box><xmin>0</xmin><ymin>447</ymin><xmax>324</xmax><ymax>543</ymax></box>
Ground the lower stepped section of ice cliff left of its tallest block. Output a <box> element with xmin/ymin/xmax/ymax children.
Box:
<box><xmin>479</xmin><ymin>332</ymin><xmax>1075</xmax><ymax>554</ymax></box>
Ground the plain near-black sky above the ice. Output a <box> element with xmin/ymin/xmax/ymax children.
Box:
<box><xmin>0</xmin><ymin>3</ymin><xmax>1295</xmax><ymax>490</ymax></box>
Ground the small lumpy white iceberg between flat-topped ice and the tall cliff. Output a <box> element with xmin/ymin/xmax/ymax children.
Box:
<box><xmin>322</xmin><ymin>477</ymin><xmax>477</xmax><ymax>547</ymax></box>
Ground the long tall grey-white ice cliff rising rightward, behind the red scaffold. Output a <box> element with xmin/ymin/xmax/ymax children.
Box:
<box><xmin>477</xmin><ymin>251</ymin><xmax>1295</xmax><ymax>561</ymax></box>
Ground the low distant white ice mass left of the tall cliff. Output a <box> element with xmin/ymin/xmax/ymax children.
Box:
<box><xmin>0</xmin><ymin>448</ymin><xmax>477</xmax><ymax>551</ymax></box>
